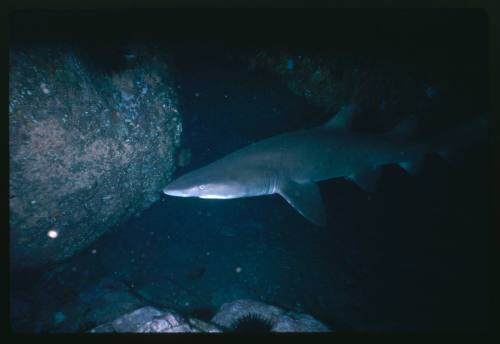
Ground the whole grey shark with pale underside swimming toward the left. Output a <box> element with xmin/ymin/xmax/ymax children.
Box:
<box><xmin>163</xmin><ymin>106</ymin><xmax>484</xmax><ymax>226</ymax></box>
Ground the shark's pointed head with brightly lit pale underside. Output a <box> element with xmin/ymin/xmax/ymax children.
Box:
<box><xmin>163</xmin><ymin>163</ymin><xmax>267</xmax><ymax>199</ymax></box>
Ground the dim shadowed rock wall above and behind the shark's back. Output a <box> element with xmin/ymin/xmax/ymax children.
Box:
<box><xmin>240</xmin><ymin>49</ymin><xmax>481</xmax><ymax>132</ymax></box>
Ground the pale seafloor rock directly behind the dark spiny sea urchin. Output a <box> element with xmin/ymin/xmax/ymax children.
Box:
<box><xmin>212</xmin><ymin>300</ymin><xmax>331</xmax><ymax>332</ymax></box>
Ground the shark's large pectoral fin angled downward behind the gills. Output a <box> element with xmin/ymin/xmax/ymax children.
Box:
<box><xmin>278</xmin><ymin>180</ymin><xmax>326</xmax><ymax>226</ymax></box>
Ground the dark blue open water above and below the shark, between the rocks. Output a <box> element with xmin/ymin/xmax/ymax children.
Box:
<box><xmin>12</xmin><ymin>9</ymin><xmax>490</xmax><ymax>331</ymax></box>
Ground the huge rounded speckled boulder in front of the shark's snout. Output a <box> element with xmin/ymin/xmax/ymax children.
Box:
<box><xmin>9</xmin><ymin>46</ymin><xmax>182</xmax><ymax>268</ymax></box>
